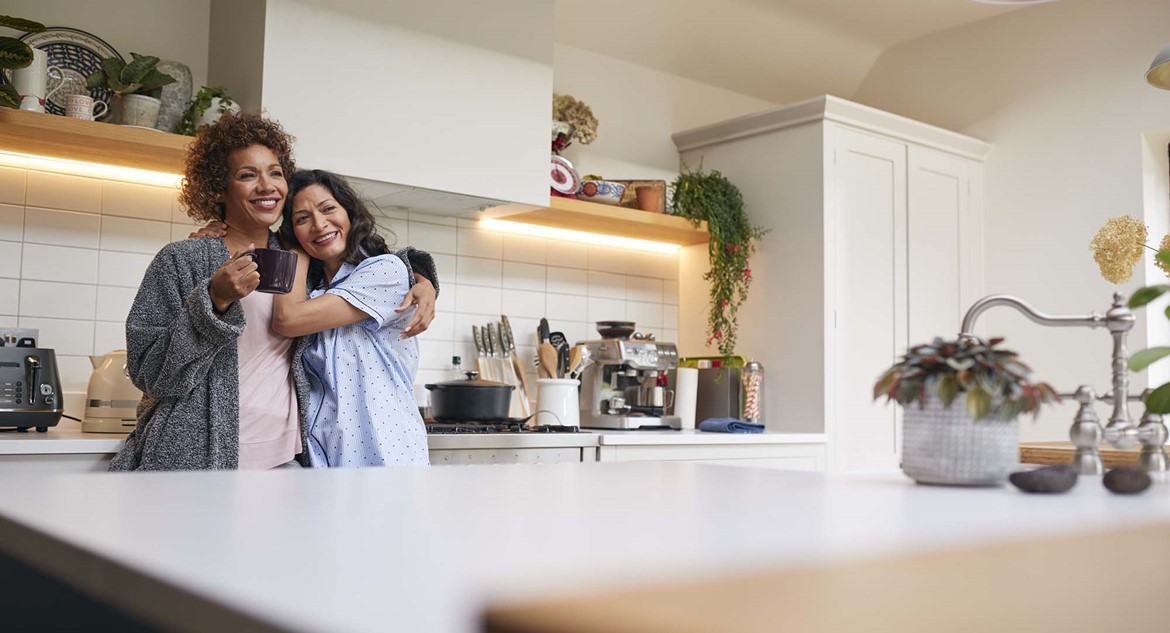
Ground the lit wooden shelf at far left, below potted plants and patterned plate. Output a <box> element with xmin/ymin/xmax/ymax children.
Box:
<box><xmin>0</xmin><ymin>108</ymin><xmax>192</xmax><ymax>173</ymax></box>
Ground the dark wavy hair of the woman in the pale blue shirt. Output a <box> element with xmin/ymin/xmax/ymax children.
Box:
<box><xmin>281</xmin><ymin>170</ymin><xmax>394</xmax><ymax>288</ymax></box>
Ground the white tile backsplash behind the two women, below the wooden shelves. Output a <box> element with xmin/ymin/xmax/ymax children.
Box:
<box><xmin>0</xmin><ymin>162</ymin><xmax>679</xmax><ymax>392</ymax></box>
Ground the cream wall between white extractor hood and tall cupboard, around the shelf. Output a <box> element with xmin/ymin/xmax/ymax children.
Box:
<box><xmin>553</xmin><ymin>44</ymin><xmax>776</xmax><ymax>356</ymax></box>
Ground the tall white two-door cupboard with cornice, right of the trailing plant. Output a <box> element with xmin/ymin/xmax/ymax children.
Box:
<box><xmin>674</xmin><ymin>96</ymin><xmax>990</xmax><ymax>472</ymax></box>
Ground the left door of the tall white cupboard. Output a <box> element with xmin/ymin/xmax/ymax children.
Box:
<box><xmin>826</xmin><ymin>128</ymin><xmax>907</xmax><ymax>470</ymax></box>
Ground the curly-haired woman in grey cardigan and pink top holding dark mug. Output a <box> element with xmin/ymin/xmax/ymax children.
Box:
<box><xmin>110</xmin><ymin>115</ymin><xmax>435</xmax><ymax>470</ymax></box>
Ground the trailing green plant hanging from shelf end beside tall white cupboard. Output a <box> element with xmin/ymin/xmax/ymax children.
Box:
<box><xmin>670</xmin><ymin>166</ymin><xmax>768</xmax><ymax>356</ymax></box>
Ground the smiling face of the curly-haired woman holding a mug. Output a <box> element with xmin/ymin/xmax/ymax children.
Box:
<box><xmin>223</xmin><ymin>145</ymin><xmax>289</xmax><ymax>232</ymax></box>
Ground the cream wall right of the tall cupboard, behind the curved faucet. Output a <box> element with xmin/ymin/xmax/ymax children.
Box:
<box><xmin>853</xmin><ymin>0</ymin><xmax>1170</xmax><ymax>440</ymax></box>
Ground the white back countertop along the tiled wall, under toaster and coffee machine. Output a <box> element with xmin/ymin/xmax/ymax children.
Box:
<box><xmin>0</xmin><ymin>427</ymin><xmax>825</xmax><ymax>455</ymax></box>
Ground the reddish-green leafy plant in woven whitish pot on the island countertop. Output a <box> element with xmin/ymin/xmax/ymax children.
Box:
<box><xmin>874</xmin><ymin>336</ymin><xmax>1060</xmax><ymax>486</ymax></box>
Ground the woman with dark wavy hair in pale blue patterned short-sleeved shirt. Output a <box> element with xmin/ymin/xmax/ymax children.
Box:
<box><xmin>273</xmin><ymin>170</ymin><xmax>429</xmax><ymax>467</ymax></box>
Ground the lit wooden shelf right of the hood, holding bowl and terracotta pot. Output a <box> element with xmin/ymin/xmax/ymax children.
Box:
<box><xmin>501</xmin><ymin>197</ymin><xmax>709</xmax><ymax>246</ymax></box>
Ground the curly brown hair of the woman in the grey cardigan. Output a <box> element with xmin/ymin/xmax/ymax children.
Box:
<box><xmin>179</xmin><ymin>112</ymin><xmax>296</xmax><ymax>222</ymax></box>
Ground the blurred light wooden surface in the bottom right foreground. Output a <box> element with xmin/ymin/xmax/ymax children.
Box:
<box><xmin>483</xmin><ymin>522</ymin><xmax>1170</xmax><ymax>633</ymax></box>
